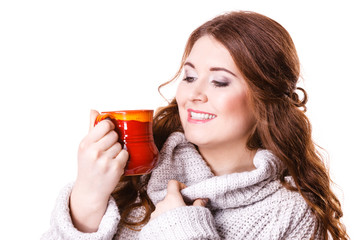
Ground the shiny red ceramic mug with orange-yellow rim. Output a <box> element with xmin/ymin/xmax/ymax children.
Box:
<box><xmin>95</xmin><ymin>110</ymin><xmax>159</xmax><ymax>176</ymax></box>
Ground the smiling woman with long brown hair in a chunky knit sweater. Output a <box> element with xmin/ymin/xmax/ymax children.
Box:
<box><xmin>44</xmin><ymin>12</ymin><xmax>347</xmax><ymax>239</ymax></box>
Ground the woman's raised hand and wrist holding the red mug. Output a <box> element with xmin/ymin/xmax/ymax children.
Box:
<box><xmin>70</xmin><ymin>111</ymin><xmax>129</xmax><ymax>232</ymax></box>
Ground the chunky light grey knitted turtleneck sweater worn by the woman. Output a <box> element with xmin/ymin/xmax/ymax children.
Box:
<box><xmin>42</xmin><ymin>133</ymin><xmax>321</xmax><ymax>240</ymax></box>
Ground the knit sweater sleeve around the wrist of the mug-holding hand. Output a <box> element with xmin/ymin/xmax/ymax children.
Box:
<box><xmin>41</xmin><ymin>184</ymin><xmax>120</xmax><ymax>240</ymax></box>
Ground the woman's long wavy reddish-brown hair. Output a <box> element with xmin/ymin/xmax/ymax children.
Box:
<box><xmin>113</xmin><ymin>11</ymin><xmax>348</xmax><ymax>239</ymax></box>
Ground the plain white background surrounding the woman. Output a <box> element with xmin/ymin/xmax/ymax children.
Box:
<box><xmin>0</xmin><ymin>0</ymin><xmax>360</xmax><ymax>239</ymax></box>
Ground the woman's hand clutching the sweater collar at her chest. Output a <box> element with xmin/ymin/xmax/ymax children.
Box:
<box><xmin>151</xmin><ymin>180</ymin><xmax>208</xmax><ymax>219</ymax></box>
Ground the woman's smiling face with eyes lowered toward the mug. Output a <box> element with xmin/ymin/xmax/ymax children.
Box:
<box><xmin>176</xmin><ymin>36</ymin><xmax>255</xmax><ymax>148</ymax></box>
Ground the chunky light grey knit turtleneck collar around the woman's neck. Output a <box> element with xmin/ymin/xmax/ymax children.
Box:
<box><xmin>148</xmin><ymin>132</ymin><xmax>283</xmax><ymax>209</ymax></box>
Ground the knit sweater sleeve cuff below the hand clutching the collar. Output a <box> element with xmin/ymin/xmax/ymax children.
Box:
<box><xmin>139</xmin><ymin>206</ymin><xmax>220</xmax><ymax>240</ymax></box>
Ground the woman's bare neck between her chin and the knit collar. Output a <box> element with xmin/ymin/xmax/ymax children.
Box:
<box><xmin>199</xmin><ymin>142</ymin><xmax>256</xmax><ymax>176</ymax></box>
